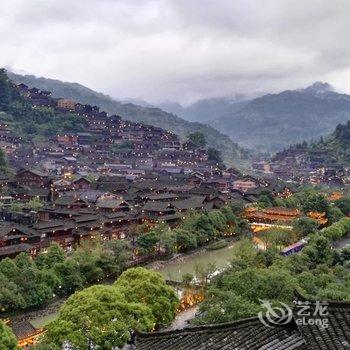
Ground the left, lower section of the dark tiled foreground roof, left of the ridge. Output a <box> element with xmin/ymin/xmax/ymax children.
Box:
<box><xmin>136</xmin><ymin>318</ymin><xmax>307</xmax><ymax>350</ymax></box>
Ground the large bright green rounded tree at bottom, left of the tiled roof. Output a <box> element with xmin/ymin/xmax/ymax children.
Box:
<box><xmin>44</xmin><ymin>285</ymin><xmax>154</xmax><ymax>350</ymax></box>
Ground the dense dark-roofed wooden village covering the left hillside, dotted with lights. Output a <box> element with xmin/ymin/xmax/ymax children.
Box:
<box><xmin>0</xmin><ymin>74</ymin><xmax>284</xmax><ymax>258</ymax></box>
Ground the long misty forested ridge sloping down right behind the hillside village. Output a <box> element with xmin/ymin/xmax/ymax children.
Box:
<box><xmin>9</xmin><ymin>72</ymin><xmax>248</xmax><ymax>164</ymax></box>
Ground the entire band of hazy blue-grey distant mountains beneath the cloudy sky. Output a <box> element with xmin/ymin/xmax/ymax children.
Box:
<box><xmin>10</xmin><ymin>69</ymin><xmax>350</xmax><ymax>154</ymax></box>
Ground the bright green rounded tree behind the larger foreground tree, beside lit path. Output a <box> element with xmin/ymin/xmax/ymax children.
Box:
<box><xmin>114</xmin><ymin>267</ymin><xmax>178</xmax><ymax>326</ymax></box>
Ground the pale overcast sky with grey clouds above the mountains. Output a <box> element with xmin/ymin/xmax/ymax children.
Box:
<box><xmin>0</xmin><ymin>0</ymin><xmax>350</xmax><ymax>103</ymax></box>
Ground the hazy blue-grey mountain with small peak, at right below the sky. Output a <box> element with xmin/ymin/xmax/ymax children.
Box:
<box><xmin>211</xmin><ymin>82</ymin><xmax>350</xmax><ymax>151</ymax></box>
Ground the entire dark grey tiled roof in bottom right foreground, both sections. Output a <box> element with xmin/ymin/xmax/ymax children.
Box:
<box><xmin>134</xmin><ymin>300</ymin><xmax>350</xmax><ymax>350</ymax></box>
